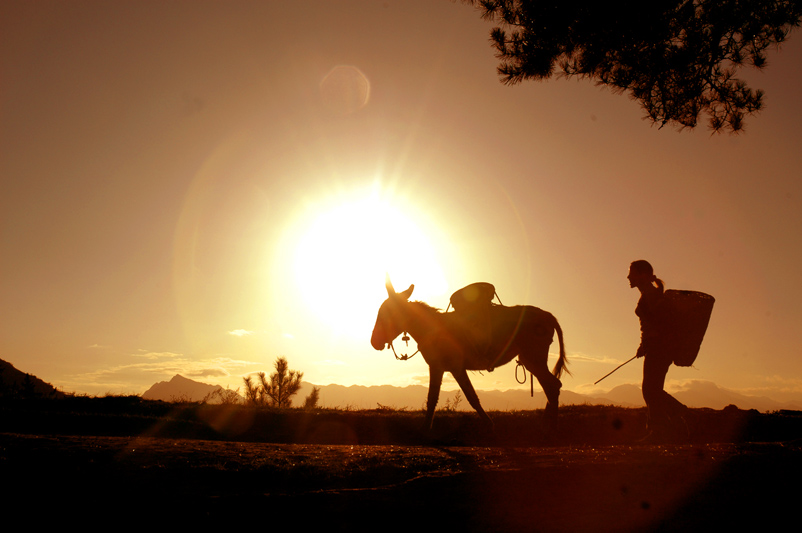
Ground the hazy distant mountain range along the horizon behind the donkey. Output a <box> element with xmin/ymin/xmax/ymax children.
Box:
<box><xmin>142</xmin><ymin>375</ymin><xmax>802</xmax><ymax>412</ymax></box>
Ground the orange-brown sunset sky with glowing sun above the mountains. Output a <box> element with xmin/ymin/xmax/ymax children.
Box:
<box><xmin>0</xmin><ymin>0</ymin><xmax>802</xmax><ymax>400</ymax></box>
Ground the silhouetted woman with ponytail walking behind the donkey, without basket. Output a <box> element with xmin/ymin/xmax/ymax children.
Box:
<box><xmin>627</xmin><ymin>260</ymin><xmax>688</xmax><ymax>440</ymax></box>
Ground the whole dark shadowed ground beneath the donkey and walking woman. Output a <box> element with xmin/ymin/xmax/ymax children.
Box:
<box><xmin>0</xmin><ymin>398</ymin><xmax>802</xmax><ymax>531</ymax></box>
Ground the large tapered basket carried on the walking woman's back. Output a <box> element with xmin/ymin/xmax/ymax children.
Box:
<box><xmin>664</xmin><ymin>289</ymin><xmax>716</xmax><ymax>366</ymax></box>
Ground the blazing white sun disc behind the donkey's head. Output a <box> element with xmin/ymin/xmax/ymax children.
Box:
<box><xmin>293</xmin><ymin>187</ymin><xmax>447</xmax><ymax>337</ymax></box>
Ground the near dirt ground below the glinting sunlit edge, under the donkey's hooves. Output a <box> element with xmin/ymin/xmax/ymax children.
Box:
<box><xmin>0</xmin><ymin>433</ymin><xmax>802</xmax><ymax>532</ymax></box>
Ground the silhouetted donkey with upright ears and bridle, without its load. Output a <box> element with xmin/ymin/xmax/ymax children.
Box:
<box><xmin>370</xmin><ymin>279</ymin><xmax>570</xmax><ymax>429</ymax></box>
